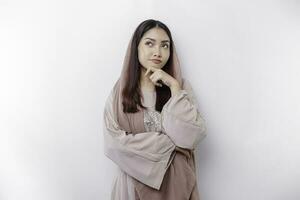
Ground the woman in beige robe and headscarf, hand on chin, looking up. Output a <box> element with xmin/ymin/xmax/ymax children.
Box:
<box><xmin>104</xmin><ymin>19</ymin><xmax>206</xmax><ymax>200</ymax></box>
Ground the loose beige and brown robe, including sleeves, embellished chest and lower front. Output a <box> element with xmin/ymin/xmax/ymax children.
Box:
<box><xmin>103</xmin><ymin>79</ymin><xmax>206</xmax><ymax>200</ymax></box>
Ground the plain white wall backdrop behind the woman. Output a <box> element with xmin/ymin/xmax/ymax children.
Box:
<box><xmin>0</xmin><ymin>0</ymin><xmax>300</xmax><ymax>200</ymax></box>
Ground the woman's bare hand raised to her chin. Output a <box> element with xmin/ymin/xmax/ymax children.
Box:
<box><xmin>145</xmin><ymin>67</ymin><xmax>180</xmax><ymax>93</ymax></box>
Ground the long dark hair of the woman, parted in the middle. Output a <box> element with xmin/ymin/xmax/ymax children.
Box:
<box><xmin>122</xmin><ymin>19</ymin><xmax>174</xmax><ymax>113</ymax></box>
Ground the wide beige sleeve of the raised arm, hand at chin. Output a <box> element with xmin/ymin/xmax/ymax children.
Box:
<box><xmin>161</xmin><ymin>79</ymin><xmax>206</xmax><ymax>150</ymax></box>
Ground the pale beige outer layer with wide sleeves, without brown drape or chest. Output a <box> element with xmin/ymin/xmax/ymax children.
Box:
<box><xmin>103</xmin><ymin>79</ymin><xmax>206</xmax><ymax>200</ymax></box>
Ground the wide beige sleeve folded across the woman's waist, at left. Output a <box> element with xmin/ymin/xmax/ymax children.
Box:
<box><xmin>103</xmin><ymin>88</ymin><xmax>176</xmax><ymax>189</ymax></box>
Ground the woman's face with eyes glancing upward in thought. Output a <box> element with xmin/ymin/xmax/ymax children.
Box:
<box><xmin>138</xmin><ymin>27</ymin><xmax>170</xmax><ymax>69</ymax></box>
